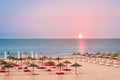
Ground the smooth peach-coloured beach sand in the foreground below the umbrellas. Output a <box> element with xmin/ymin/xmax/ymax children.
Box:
<box><xmin>0</xmin><ymin>59</ymin><xmax>120</xmax><ymax>80</ymax></box>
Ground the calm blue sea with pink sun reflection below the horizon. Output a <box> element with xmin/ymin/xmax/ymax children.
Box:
<box><xmin>0</xmin><ymin>39</ymin><xmax>120</xmax><ymax>57</ymax></box>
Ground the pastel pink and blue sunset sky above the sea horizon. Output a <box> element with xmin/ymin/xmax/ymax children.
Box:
<box><xmin>0</xmin><ymin>0</ymin><xmax>120</xmax><ymax>38</ymax></box>
